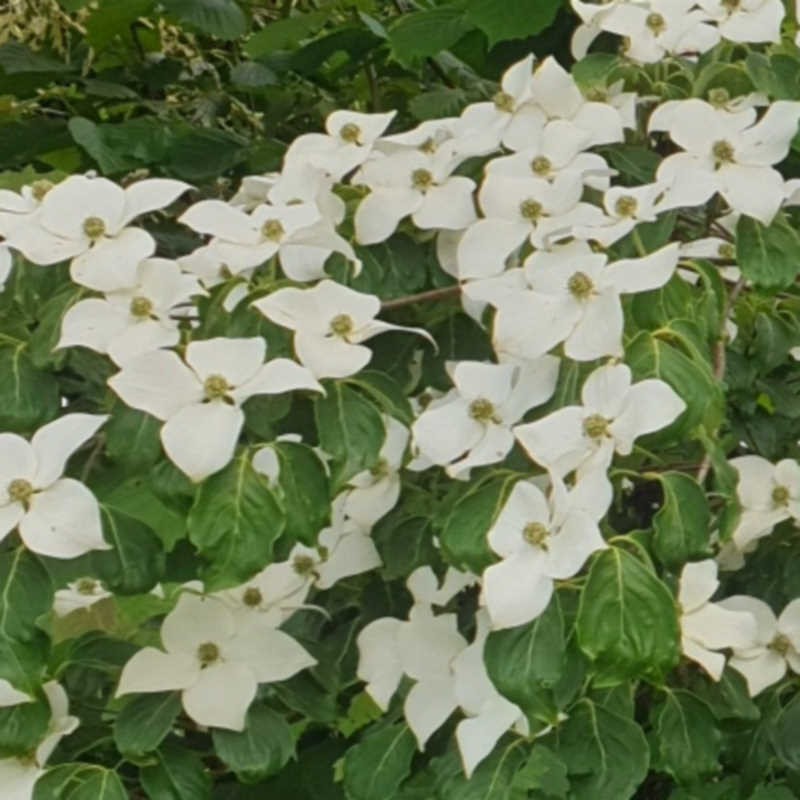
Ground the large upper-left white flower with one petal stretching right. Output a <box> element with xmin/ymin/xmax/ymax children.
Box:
<box><xmin>7</xmin><ymin>175</ymin><xmax>191</xmax><ymax>292</ymax></box>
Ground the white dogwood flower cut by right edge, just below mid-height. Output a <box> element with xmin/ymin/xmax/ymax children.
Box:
<box><xmin>728</xmin><ymin>456</ymin><xmax>800</xmax><ymax>550</ymax></box>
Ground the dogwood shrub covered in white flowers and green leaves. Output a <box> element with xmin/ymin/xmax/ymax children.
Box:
<box><xmin>6</xmin><ymin>0</ymin><xmax>800</xmax><ymax>800</ymax></box>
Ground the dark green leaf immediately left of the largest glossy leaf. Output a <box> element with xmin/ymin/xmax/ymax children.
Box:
<box><xmin>483</xmin><ymin>597</ymin><xmax>566</xmax><ymax>722</ymax></box>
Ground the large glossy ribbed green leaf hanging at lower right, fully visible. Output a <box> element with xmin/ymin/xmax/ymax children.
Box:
<box><xmin>577</xmin><ymin>547</ymin><xmax>680</xmax><ymax>686</ymax></box>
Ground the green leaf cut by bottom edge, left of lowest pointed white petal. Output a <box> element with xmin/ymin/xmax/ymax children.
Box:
<box><xmin>344</xmin><ymin>723</ymin><xmax>417</xmax><ymax>800</ymax></box>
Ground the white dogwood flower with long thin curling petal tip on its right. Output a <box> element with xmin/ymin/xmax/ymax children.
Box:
<box><xmin>253</xmin><ymin>280</ymin><xmax>430</xmax><ymax>378</ymax></box>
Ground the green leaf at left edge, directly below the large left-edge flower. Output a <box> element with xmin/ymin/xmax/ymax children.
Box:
<box><xmin>0</xmin><ymin>547</ymin><xmax>53</xmax><ymax>641</ymax></box>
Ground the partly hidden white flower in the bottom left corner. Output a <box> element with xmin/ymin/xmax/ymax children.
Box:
<box><xmin>0</xmin><ymin>681</ymin><xmax>80</xmax><ymax>800</ymax></box>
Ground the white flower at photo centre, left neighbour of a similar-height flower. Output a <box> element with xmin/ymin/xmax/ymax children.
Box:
<box><xmin>412</xmin><ymin>356</ymin><xmax>559</xmax><ymax>477</ymax></box>
